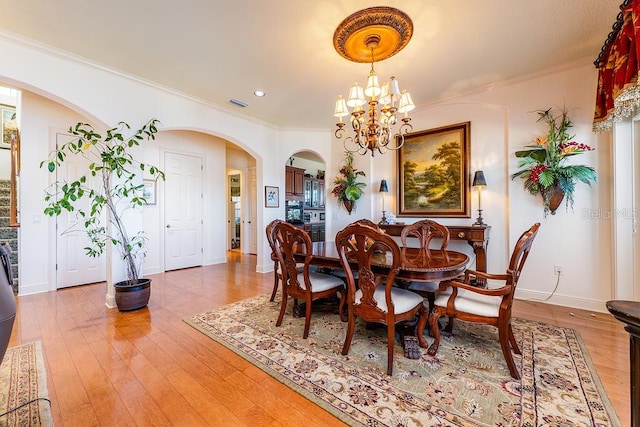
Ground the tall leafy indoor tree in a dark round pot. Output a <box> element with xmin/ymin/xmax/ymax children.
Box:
<box><xmin>40</xmin><ymin>119</ymin><xmax>164</xmax><ymax>311</ymax></box>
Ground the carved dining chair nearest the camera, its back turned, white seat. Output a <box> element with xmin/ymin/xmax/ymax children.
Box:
<box><xmin>336</xmin><ymin>223</ymin><xmax>427</xmax><ymax>375</ymax></box>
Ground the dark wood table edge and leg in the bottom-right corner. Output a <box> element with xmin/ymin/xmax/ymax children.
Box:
<box><xmin>607</xmin><ymin>300</ymin><xmax>640</xmax><ymax>427</ymax></box>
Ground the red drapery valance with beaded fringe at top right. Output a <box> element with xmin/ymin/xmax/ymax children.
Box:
<box><xmin>593</xmin><ymin>0</ymin><xmax>640</xmax><ymax>131</ymax></box>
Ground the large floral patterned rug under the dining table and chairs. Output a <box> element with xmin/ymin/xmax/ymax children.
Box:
<box><xmin>184</xmin><ymin>295</ymin><xmax>620</xmax><ymax>426</ymax></box>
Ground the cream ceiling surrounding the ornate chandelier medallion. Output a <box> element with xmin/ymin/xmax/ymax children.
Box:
<box><xmin>0</xmin><ymin>0</ymin><xmax>621</xmax><ymax>129</ymax></box>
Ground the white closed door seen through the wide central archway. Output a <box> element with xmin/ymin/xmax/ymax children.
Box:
<box><xmin>164</xmin><ymin>152</ymin><xmax>202</xmax><ymax>270</ymax></box>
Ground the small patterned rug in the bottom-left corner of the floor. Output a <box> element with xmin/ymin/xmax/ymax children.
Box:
<box><xmin>0</xmin><ymin>341</ymin><xmax>53</xmax><ymax>427</ymax></box>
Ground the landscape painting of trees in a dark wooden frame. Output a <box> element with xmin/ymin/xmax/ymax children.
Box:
<box><xmin>397</xmin><ymin>122</ymin><xmax>471</xmax><ymax>218</ymax></box>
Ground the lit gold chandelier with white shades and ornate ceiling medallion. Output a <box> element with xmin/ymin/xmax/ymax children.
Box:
<box><xmin>333</xmin><ymin>6</ymin><xmax>415</xmax><ymax>156</ymax></box>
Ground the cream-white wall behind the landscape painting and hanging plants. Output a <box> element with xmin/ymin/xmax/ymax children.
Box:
<box><xmin>327</xmin><ymin>61</ymin><xmax>613</xmax><ymax>312</ymax></box>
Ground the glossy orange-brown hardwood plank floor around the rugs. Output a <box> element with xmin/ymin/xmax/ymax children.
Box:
<box><xmin>10</xmin><ymin>252</ymin><xmax>630</xmax><ymax>427</ymax></box>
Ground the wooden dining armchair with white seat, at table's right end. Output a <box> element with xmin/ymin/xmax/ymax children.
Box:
<box><xmin>418</xmin><ymin>223</ymin><xmax>540</xmax><ymax>379</ymax></box>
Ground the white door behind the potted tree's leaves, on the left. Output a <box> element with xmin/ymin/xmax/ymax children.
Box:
<box><xmin>56</xmin><ymin>134</ymin><xmax>107</xmax><ymax>289</ymax></box>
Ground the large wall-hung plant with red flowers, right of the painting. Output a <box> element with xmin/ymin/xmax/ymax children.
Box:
<box><xmin>511</xmin><ymin>108</ymin><xmax>597</xmax><ymax>216</ymax></box>
